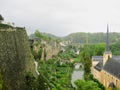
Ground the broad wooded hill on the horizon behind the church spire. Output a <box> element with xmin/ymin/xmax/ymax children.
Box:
<box><xmin>64</xmin><ymin>32</ymin><xmax>120</xmax><ymax>44</ymax></box>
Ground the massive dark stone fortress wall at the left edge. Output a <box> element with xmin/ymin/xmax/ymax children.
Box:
<box><xmin>0</xmin><ymin>28</ymin><xmax>34</xmax><ymax>90</ymax></box>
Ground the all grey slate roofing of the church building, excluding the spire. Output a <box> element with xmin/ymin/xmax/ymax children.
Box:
<box><xmin>92</xmin><ymin>56</ymin><xmax>120</xmax><ymax>78</ymax></box>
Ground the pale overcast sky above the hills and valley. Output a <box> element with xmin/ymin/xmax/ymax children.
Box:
<box><xmin>0</xmin><ymin>0</ymin><xmax>120</xmax><ymax>36</ymax></box>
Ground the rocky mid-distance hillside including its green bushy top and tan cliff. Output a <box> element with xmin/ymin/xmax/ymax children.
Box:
<box><xmin>29</xmin><ymin>31</ymin><xmax>61</xmax><ymax>60</ymax></box>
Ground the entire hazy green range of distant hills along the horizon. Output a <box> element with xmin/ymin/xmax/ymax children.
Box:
<box><xmin>29</xmin><ymin>32</ymin><xmax>120</xmax><ymax>44</ymax></box>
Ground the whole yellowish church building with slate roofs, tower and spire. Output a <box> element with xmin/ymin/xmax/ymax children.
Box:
<box><xmin>91</xmin><ymin>26</ymin><xmax>120</xmax><ymax>88</ymax></box>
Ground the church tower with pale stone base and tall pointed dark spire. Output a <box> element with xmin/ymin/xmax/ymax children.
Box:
<box><xmin>103</xmin><ymin>24</ymin><xmax>112</xmax><ymax>66</ymax></box>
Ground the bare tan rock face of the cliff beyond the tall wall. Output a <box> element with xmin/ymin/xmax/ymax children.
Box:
<box><xmin>34</xmin><ymin>41</ymin><xmax>61</xmax><ymax>60</ymax></box>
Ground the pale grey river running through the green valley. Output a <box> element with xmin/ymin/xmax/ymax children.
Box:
<box><xmin>71</xmin><ymin>64</ymin><xmax>84</xmax><ymax>87</ymax></box>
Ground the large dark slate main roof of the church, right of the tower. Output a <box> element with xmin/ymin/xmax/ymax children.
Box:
<box><xmin>103</xmin><ymin>56</ymin><xmax>120</xmax><ymax>79</ymax></box>
